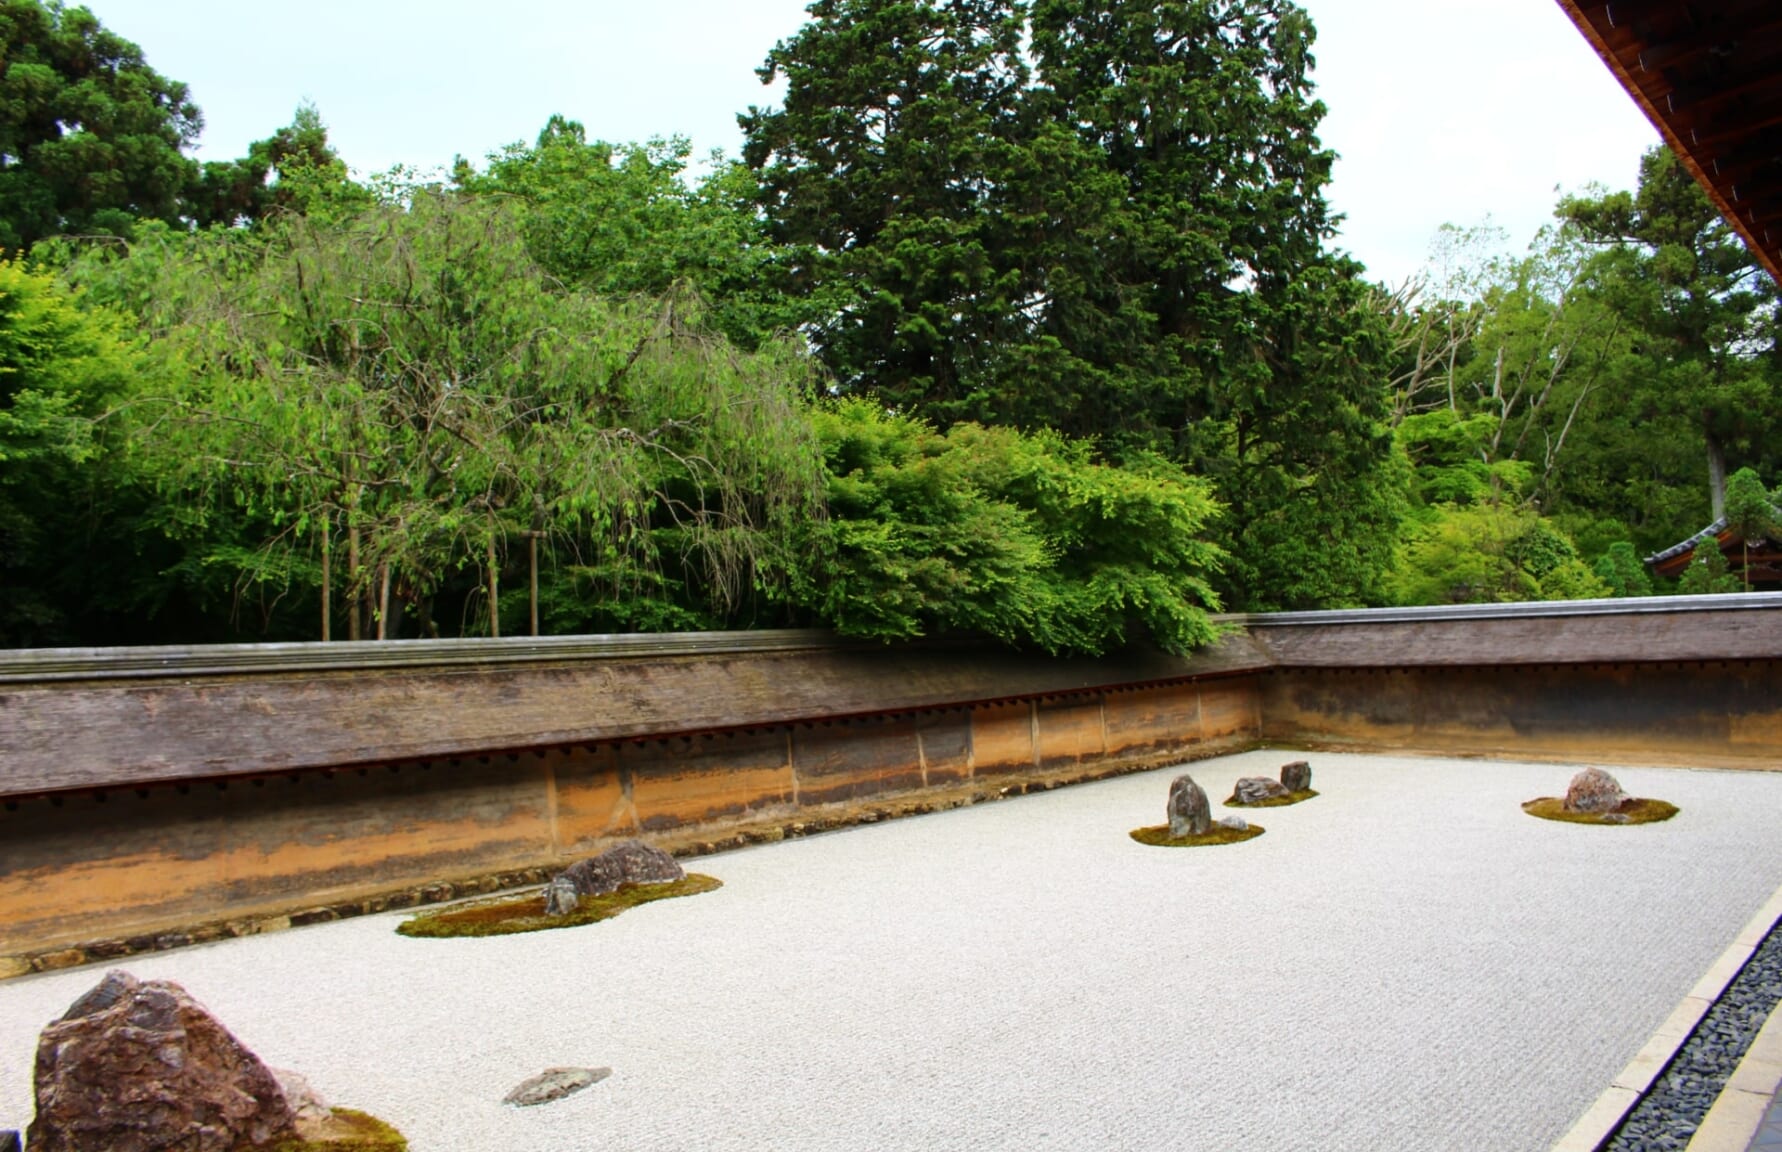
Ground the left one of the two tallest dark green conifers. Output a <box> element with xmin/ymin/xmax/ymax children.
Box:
<box><xmin>740</xmin><ymin>0</ymin><xmax>1032</xmax><ymax>415</ymax></box>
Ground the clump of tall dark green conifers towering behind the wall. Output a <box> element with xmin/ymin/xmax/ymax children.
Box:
<box><xmin>741</xmin><ymin>0</ymin><xmax>1404</xmax><ymax>608</ymax></box>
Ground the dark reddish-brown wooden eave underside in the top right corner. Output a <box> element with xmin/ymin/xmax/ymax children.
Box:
<box><xmin>1559</xmin><ymin>0</ymin><xmax>1782</xmax><ymax>282</ymax></box>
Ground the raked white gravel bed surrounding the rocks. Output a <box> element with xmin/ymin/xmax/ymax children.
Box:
<box><xmin>0</xmin><ymin>751</ymin><xmax>1782</xmax><ymax>1152</ymax></box>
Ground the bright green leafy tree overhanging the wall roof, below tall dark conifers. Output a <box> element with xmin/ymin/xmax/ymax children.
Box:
<box><xmin>797</xmin><ymin>401</ymin><xmax>1221</xmax><ymax>653</ymax></box>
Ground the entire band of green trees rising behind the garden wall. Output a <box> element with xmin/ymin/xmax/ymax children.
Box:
<box><xmin>0</xmin><ymin>0</ymin><xmax>1782</xmax><ymax>653</ymax></box>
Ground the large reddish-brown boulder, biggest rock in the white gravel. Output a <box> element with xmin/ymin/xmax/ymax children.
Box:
<box><xmin>27</xmin><ymin>970</ymin><xmax>298</xmax><ymax>1152</ymax></box>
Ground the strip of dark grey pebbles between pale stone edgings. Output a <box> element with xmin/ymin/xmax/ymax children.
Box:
<box><xmin>1606</xmin><ymin>927</ymin><xmax>1782</xmax><ymax>1152</ymax></box>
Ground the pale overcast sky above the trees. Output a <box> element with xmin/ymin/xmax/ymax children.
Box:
<box><xmin>86</xmin><ymin>0</ymin><xmax>1657</xmax><ymax>282</ymax></box>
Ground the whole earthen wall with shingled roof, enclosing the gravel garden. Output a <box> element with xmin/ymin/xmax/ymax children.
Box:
<box><xmin>0</xmin><ymin>594</ymin><xmax>1782</xmax><ymax>977</ymax></box>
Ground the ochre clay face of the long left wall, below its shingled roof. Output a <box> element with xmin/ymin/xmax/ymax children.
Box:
<box><xmin>0</xmin><ymin>676</ymin><xmax>1260</xmax><ymax>974</ymax></box>
